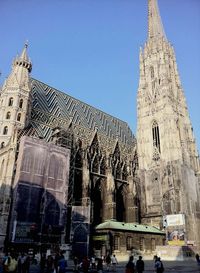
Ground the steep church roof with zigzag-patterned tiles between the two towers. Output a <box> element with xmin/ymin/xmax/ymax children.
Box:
<box><xmin>31</xmin><ymin>78</ymin><xmax>135</xmax><ymax>145</ymax></box>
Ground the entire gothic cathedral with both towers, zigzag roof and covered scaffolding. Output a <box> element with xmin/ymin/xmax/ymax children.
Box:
<box><xmin>0</xmin><ymin>0</ymin><xmax>200</xmax><ymax>255</ymax></box>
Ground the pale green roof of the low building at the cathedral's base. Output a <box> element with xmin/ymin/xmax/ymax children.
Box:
<box><xmin>96</xmin><ymin>220</ymin><xmax>165</xmax><ymax>235</ymax></box>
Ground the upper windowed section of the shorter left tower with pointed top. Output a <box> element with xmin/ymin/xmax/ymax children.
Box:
<box><xmin>0</xmin><ymin>44</ymin><xmax>32</xmax><ymax>148</ymax></box>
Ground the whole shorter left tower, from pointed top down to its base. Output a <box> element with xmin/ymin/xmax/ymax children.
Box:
<box><xmin>0</xmin><ymin>44</ymin><xmax>32</xmax><ymax>247</ymax></box>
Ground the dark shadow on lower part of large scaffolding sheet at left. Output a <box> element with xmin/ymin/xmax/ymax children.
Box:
<box><xmin>6</xmin><ymin>181</ymin><xmax>67</xmax><ymax>250</ymax></box>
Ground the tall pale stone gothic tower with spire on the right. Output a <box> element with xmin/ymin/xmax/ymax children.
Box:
<box><xmin>137</xmin><ymin>0</ymin><xmax>200</xmax><ymax>244</ymax></box>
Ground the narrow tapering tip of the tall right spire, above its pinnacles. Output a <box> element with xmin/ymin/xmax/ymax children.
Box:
<box><xmin>148</xmin><ymin>0</ymin><xmax>166</xmax><ymax>39</ymax></box>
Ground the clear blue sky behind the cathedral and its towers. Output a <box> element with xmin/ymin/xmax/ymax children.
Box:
<box><xmin>0</xmin><ymin>0</ymin><xmax>200</xmax><ymax>151</ymax></box>
